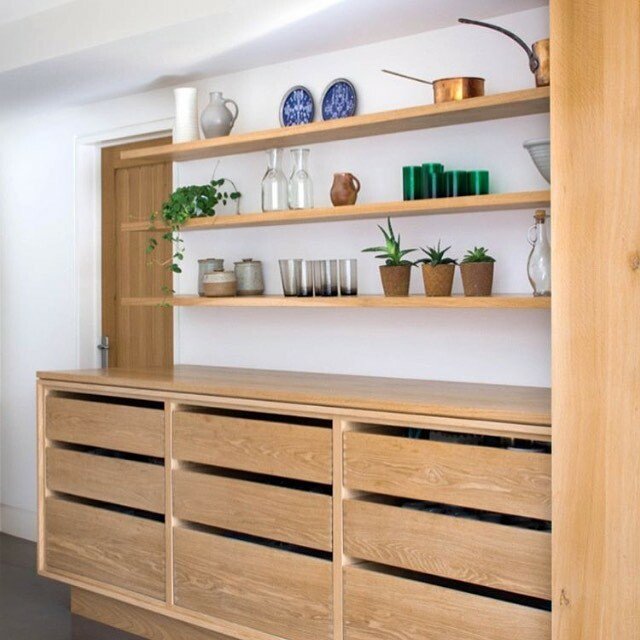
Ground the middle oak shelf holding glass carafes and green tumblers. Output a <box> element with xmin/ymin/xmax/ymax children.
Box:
<box><xmin>121</xmin><ymin>191</ymin><xmax>551</xmax><ymax>231</ymax></box>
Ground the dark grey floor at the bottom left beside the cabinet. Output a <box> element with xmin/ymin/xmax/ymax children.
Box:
<box><xmin>0</xmin><ymin>533</ymin><xmax>140</xmax><ymax>640</ymax></box>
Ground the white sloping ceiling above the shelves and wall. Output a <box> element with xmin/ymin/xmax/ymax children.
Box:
<box><xmin>0</xmin><ymin>0</ymin><xmax>547</xmax><ymax>113</ymax></box>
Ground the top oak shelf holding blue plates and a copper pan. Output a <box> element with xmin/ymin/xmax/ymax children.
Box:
<box><xmin>121</xmin><ymin>87</ymin><xmax>549</xmax><ymax>162</ymax></box>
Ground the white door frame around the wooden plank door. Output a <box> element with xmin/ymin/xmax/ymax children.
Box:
<box><xmin>73</xmin><ymin>118</ymin><xmax>179</xmax><ymax>369</ymax></box>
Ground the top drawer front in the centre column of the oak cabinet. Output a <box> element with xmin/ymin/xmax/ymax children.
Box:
<box><xmin>174</xmin><ymin>412</ymin><xmax>331</xmax><ymax>484</ymax></box>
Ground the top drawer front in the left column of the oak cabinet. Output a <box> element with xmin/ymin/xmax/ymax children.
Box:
<box><xmin>45</xmin><ymin>396</ymin><xmax>164</xmax><ymax>458</ymax></box>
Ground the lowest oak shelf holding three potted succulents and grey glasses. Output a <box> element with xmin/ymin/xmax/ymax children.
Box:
<box><xmin>122</xmin><ymin>295</ymin><xmax>551</xmax><ymax>309</ymax></box>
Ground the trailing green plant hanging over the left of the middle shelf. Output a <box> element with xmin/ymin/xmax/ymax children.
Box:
<box><xmin>146</xmin><ymin>178</ymin><xmax>241</xmax><ymax>278</ymax></box>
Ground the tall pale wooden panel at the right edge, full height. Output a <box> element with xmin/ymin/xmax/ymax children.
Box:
<box><xmin>551</xmin><ymin>0</ymin><xmax>640</xmax><ymax>640</ymax></box>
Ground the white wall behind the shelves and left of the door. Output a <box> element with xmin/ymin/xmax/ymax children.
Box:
<box><xmin>0</xmin><ymin>9</ymin><xmax>550</xmax><ymax>537</ymax></box>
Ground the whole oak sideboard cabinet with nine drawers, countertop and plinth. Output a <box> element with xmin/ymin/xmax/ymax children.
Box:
<box><xmin>38</xmin><ymin>366</ymin><xmax>551</xmax><ymax>640</ymax></box>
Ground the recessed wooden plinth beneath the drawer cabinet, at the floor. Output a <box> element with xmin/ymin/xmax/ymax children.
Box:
<box><xmin>71</xmin><ymin>587</ymin><xmax>231</xmax><ymax>640</ymax></box>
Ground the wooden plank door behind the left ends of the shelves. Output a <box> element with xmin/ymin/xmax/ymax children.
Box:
<box><xmin>102</xmin><ymin>138</ymin><xmax>173</xmax><ymax>367</ymax></box>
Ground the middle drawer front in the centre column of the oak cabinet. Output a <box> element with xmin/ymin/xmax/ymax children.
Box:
<box><xmin>173</xmin><ymin>470</ymin><xmax>331</xmax><ymax>551</ymax></box>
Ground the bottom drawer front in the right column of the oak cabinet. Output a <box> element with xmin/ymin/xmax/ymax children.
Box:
<box><xmin>344</xmin><ymin>566</ymin><xmax>551</xmax><ymax>640</ymax></box>
